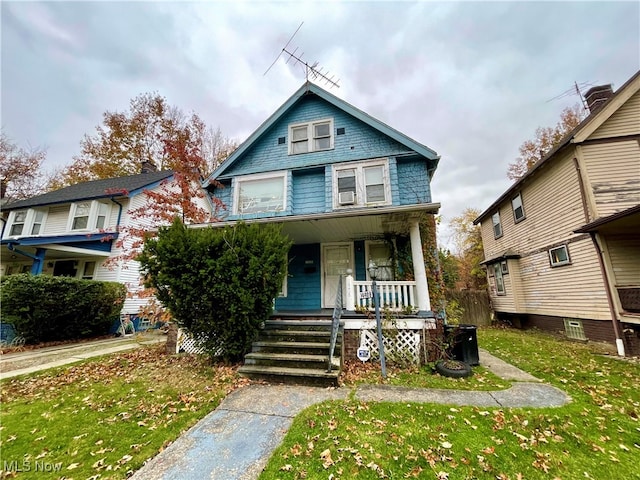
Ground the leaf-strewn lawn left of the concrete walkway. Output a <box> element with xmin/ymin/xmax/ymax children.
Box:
<box><xmin>0</xmin><ymin>347</ymin><xmax>241</xmax><ymax>480</ymax></box>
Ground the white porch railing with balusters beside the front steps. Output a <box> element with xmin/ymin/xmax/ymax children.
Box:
<box><xmin>345</xmin><ymin>275</ymin><xmax>418</xmax><ymax>312</ymax></box>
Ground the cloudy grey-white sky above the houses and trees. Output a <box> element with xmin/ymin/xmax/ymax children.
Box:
<box><xmin>0</xmin><ymin>1</ymin><xmax>640</xmax><ymax>251</ymax></box>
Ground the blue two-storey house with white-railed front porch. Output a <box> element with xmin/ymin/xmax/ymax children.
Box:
<box><xmin>207</xmin><ymin>82</ymin><xmax>440</xmax><ymax>376</ymax></box>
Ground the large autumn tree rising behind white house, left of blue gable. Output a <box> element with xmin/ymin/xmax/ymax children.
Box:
<box><xmin>49</xmin><ymin>93</ymin><xmax>235</xmax><ymax>189</ymax></box>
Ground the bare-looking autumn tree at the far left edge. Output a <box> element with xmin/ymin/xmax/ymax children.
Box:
<box><xmin>0</xmin><ymin>132</ymin><xmax>46</xmax><ymax>200</ymax></box>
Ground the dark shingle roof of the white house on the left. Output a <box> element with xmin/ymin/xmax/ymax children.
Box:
<box><xmin>2</xmin><ymin>170</ymin><xmax>173</xmax><ymax>210</ymax></box>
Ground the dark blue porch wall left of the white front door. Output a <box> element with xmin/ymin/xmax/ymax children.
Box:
<box><xmin>276</xmin><ymin>243</ymin><xmax>322</xmax><ymax>310</ymax></box>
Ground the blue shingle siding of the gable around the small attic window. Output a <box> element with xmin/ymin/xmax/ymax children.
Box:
<box><xmin>218</xmin><ymin>95</ymin><xmax>411</xmax><ymax>178</ymax></box>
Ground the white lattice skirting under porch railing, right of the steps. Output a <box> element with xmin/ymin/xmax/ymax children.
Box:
<box><xmin>360</xmin><ymin>329</ymin><xmax>422</xmax><ymax>364</ymax></box>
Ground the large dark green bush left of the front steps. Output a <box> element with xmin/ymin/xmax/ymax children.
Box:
<box><xmin>138</xmin><ymin>219</ymin><xmax>291</xmax><ymax>361</ymax></box>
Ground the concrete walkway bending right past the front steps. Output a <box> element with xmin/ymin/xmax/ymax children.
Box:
<box><xmin>131</xmin><ymin>350</ymin><xmax>571</xmax><ymax>480</ymax></box>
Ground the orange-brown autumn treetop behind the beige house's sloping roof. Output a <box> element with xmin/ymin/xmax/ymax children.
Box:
<box><xmin>507</xmin><ymin>104</ymin><xmax>584</xmax><ymax>181</ymax></box>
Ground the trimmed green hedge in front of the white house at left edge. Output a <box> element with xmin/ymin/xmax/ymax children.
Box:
<box><xmin>0</xmin><ymin>274</ymin><xmax>126</xmax><ymax>343</ymax></box>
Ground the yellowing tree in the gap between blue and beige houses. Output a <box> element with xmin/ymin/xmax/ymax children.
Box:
<box><xmin>450</xmin><ymin>208</ymin><xmax>487</xmax><ymax>289</ymax></box>
